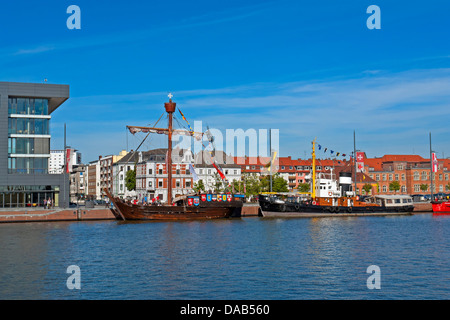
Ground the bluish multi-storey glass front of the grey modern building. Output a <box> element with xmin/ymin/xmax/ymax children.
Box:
<box><xmin>8</xmin><ymin>97</ymin><xmax>50</xmax><ymax>174</ymax></box>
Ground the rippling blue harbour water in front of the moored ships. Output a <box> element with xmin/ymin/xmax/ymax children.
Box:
<box><xmin>0</xmin><ymin>214</ymin><xmax>450</xmax><ymax>300</ymax></box>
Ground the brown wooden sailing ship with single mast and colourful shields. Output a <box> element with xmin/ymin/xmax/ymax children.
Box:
<box><xmin>103</xmin><ymin>94</ymin><xmax>244</xmax><ymax>220</ymax></box>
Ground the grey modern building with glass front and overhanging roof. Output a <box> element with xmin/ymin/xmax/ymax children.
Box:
<box><xmin>0</xmin><ymin>82</ymin><xmax>69</xmax><ymax>208</ymax></box>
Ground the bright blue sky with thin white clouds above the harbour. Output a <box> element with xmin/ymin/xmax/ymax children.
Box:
<box><xmin>0</xmin><ymin>0</ymin><xmax>450</xmax><ymax>162</ymax></box>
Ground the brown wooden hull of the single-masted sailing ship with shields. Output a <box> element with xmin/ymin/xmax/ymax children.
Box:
<box><xmin>112</xmin><ymin>200</ymin><xmax>242</xmax><ymax>220</ymax></box>
